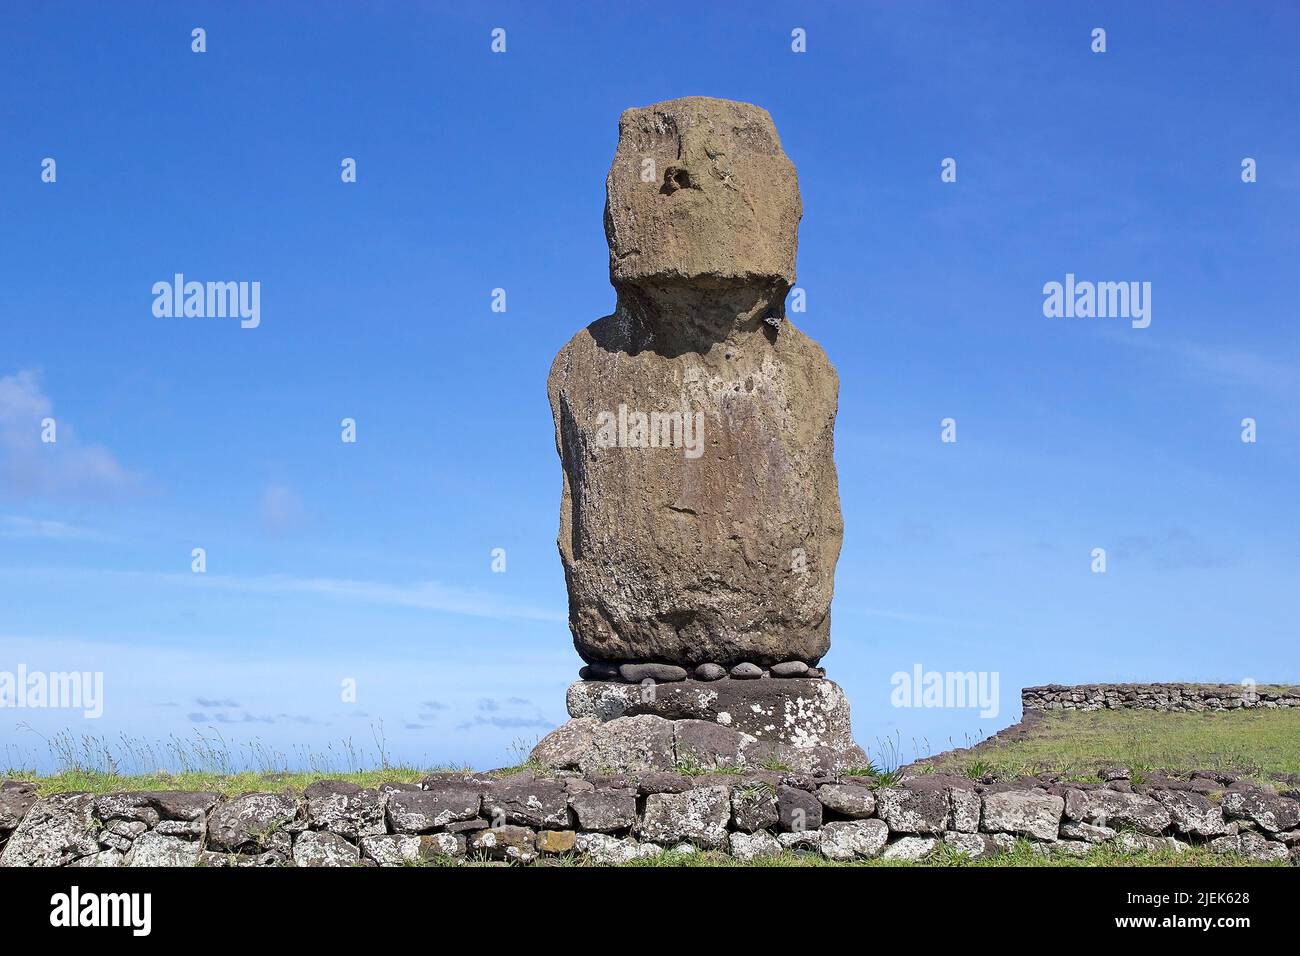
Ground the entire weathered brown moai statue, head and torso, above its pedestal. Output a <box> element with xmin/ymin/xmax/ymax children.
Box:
<box><xmin>547</xmin><ymin>98</ymin><xmax>842</xmax><ymax>666</ymax></box>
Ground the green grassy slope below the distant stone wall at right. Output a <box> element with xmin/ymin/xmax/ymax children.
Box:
<box><xmin>927</xmin><ymin>709</ymin><xmax>1300</xmax><ymax>782</ymax></box>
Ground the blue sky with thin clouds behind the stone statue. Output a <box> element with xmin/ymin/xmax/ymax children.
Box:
<box><xmin>0</xmin><ymin>3</ymin><xmax>1300</xmax><ymax>767</ymax></box>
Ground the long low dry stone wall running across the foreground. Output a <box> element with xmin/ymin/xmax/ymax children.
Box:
<box><xmin>0</xmin><ymin>769</ymin><xmax>1300</xmax><ymax>866</ymax></box>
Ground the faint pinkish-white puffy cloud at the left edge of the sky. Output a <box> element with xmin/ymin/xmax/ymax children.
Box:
<box><xmin>0</xmin><ymin>369</ymin><xmax>131</xmax><ymax>496</ymax></box>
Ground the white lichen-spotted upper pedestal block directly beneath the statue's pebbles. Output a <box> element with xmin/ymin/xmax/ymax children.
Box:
<box><xmin>567</xmin><ymin>678</ymin><xmax>867</xmax><ymax>766</ymax></box>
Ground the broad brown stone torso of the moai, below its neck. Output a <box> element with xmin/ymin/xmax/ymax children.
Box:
<box><xmin>549</xmin><ymin>313</ymin><xmax>842</xmax><ymax>666</ymax></box>
